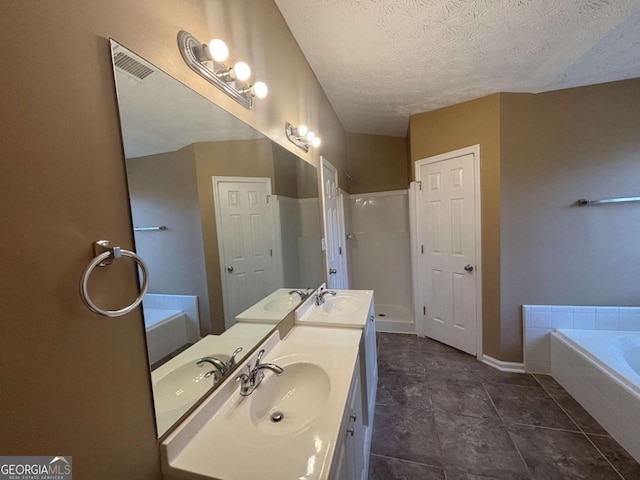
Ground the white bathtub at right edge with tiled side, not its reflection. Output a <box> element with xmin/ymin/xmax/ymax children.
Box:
<box><xmin>551</xmin><ymin>329</ymin><xmax>640</xmax><ymax>462</ymax></box>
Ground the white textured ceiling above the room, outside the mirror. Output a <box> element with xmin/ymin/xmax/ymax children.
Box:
<box><xmin>275</xmin><ymin>0</ymin><xmax>640</xmax><ymax>136</ymax></box>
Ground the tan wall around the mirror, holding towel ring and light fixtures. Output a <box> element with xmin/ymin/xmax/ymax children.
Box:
<box><xmin>0</xmin><ymin>0</ymin><xmax>346</xmax><ymax>480</ymax></box>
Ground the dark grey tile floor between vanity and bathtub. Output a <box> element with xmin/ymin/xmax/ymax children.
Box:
<box><xmin>369</xmin><ymin>333</ymin><xmax>640</xmax><ymax>480</ymax></box>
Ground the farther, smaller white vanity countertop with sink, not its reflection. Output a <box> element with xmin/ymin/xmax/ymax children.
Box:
<box><xmin>295</xmin><ymin>290</ymin><xmax>373</xmax><ymax>328</ymax></box>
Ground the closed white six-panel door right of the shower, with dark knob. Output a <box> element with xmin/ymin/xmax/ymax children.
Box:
<box><xmin>416</xmin><ymin>149</ymin><xmax>481</xmax><ymax>355</ymax></box>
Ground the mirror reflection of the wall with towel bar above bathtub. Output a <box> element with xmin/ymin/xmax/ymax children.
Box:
<box><xmin>126</xmin><ymin>145</ymin><xmax>212</xmax><ymax>335</ymax></box>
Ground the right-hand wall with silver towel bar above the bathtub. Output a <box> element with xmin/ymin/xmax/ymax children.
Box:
<box><xmin>499</xmin><ymin>79</ymin><xmax>640</xmax><ymax>361</ymax></box>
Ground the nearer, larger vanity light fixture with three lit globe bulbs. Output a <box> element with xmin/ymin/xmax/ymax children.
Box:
<box><xmin>178</xmin><ymin>30</ymin><xmax>269</xmax><ymax>108</ymax></box>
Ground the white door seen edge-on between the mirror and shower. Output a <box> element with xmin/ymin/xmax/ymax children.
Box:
<box><xmin>320</xmin><ymin>157</ymin><xmax>348</xmax><ymax>289</ymax></box>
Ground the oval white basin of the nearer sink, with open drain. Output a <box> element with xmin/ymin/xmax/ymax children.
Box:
<box><xmin>249</xmin><ymin>362</ymin><xmax>331</xmax><ymax>435</ymax></box>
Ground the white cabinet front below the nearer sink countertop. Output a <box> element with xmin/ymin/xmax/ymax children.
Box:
<box><xmin>329</xmin><ymin>360</ymin><xmax>369</xmax><ymax>480</ymax></box>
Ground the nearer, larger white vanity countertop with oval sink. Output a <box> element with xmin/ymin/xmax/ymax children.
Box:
<box><xmin>161</xmin><ymin>326</ymin><xmax>362</xmax><ymax>480</ymax></box>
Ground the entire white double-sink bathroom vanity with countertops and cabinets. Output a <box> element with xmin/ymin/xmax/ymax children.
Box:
<box><xmin>161</xmin><ymin>290</ymin><xmax>377</xmax><ymax>480</ymax></box>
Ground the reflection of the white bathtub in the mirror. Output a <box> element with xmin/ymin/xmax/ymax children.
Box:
<box><xmin>143</xmin><ymin>308</ymin><xmax>189</xmax><ymax>364</ymax></box>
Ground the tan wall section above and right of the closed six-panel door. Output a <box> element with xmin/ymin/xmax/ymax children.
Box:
<box><xmin>409</xmin><ymin>95</ymin><xmax>500</xmax><ymax>358</ymax></box>
